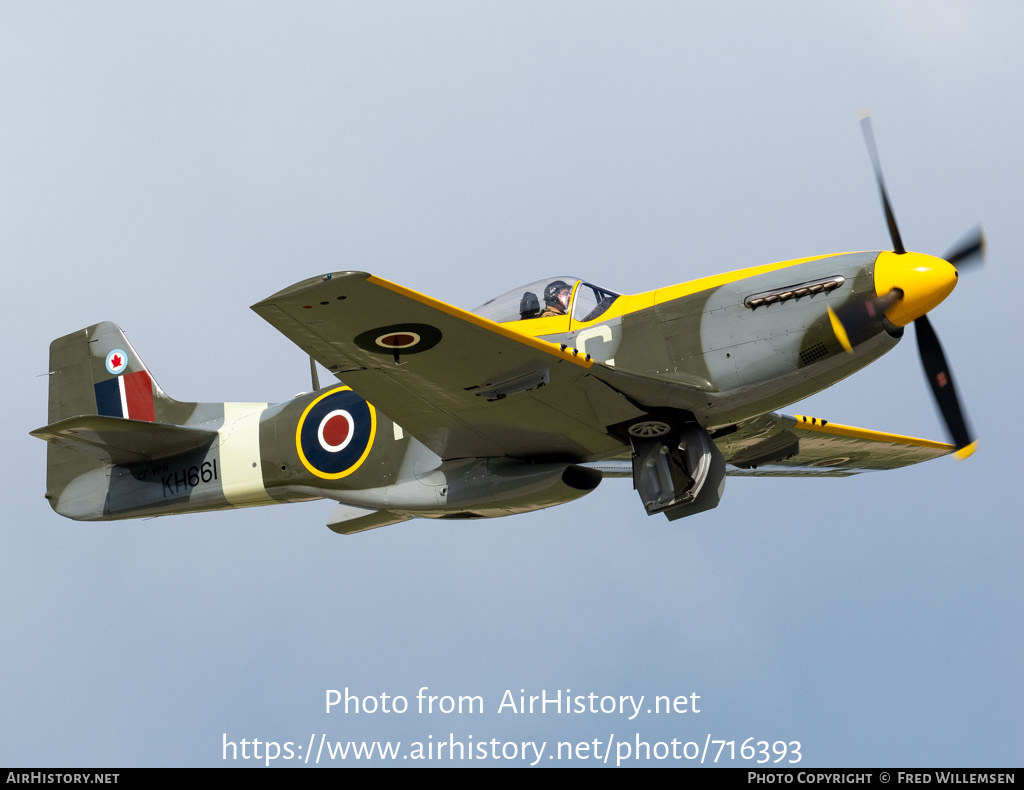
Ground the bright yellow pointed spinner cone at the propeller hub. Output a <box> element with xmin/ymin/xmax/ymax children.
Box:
<box><xmin>874</xmin><ymin>252</ymin><xmax>957</xmax><ymax>327</ymax></box>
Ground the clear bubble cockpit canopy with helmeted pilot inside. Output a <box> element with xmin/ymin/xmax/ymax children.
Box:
<box><xmin>473</xmin><ymin>276</ymin><xmax>620</xmax><ymax>324</ymax></box>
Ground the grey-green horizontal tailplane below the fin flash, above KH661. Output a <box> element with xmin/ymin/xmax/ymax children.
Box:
<box><xmin>32</xmin><ymin>415</ymin><xmax>217</xmax><ymax>464</ymax></box>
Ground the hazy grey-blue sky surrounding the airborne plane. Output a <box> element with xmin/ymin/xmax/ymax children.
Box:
<box><xmin>0</xmin><ymin>0</ymin><xmax>1024</xmax><ymax>766</ymax></box>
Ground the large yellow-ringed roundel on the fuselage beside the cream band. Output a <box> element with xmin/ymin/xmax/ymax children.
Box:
<box><xmin>295</xmin><ymin>386</ymin><xmax>377</xmax><ymax>480</ymax></box>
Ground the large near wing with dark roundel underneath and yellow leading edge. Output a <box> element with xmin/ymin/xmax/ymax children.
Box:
<box><xmin>253</xmin><ymin>272</ymin><xmax>644</xmax><ymax>461</ymax></box>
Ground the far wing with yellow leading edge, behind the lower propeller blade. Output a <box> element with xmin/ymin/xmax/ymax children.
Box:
<box><xmin>716</xmin><ymin>414</ymin><xmax>956</xmax><ymax>477</ymax></box>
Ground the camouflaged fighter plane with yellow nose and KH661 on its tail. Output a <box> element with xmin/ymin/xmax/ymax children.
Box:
<box><xmin>32</xmin><ymin>118</ymin><xmax>984</xmax><ymax>534</ymax></box>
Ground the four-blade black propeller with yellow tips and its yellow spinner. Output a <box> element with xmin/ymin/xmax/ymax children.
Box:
<box><xmin>828</xmin><ymin>110</ymin><xmax>985</xmax><ymax>459</ymax></box>
